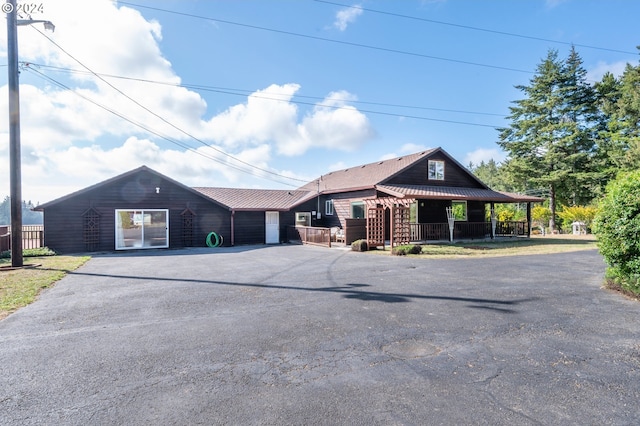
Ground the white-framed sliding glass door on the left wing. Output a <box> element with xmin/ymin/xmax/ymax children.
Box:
<box><xmin>116</xmin><ymin>209</ymin><xmax>169</xmax><ymax>250</ymax></box>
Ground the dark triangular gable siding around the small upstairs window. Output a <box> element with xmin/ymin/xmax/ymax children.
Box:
<box><xmin>383</xmin><ymin>152</ymin><xmax>483</xmax><ymax>188</ymax></box>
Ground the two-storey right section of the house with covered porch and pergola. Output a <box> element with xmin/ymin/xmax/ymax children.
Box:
<box><xmin>296</xmin><ymin>148</ymin><xmax>544</xmax><ymax>245</ymax></box>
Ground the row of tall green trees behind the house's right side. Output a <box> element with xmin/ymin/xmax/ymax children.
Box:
<box><xmin>469</xmin><ymin>46</ymin><xmax>640</xmax><ymax>231</ymax></box>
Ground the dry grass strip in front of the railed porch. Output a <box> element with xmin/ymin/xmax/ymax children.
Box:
<box><xmin>372</xmin><ymin>235</ymin><xmax>597</xmax><ymax>258</ymax></box>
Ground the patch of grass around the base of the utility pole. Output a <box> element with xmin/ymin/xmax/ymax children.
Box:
<box><xmin>0</xmin><ymin>250</ymin><xmax>90</xmax><ymax>320</ymax></box>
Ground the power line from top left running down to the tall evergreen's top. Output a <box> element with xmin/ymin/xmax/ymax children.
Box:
<box><xmin>118</xmin><ymin>1</ymin><xmax>534</xmax><ymax>74</ymax></box>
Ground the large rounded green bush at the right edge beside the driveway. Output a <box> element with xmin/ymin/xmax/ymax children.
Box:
<box><xmin>593</xmin><ymin>171</ymin><xmax>640</xmax><ymax>294</ymax></box>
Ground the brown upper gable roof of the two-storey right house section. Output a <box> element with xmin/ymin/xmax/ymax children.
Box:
<box><xmin>299</xmin><ymin>148</ymin><xmax>488</xmax><ymax>194</ymax></box>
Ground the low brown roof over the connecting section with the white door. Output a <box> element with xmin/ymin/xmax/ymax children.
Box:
<box><xmin>193</xmin><ymin>187</ymin><xmax>314</xmax><ymax>211</ymax></box>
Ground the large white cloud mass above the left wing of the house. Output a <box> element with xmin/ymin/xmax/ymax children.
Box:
<box><xmin>0</xmin><ymin>0</ymin><xmax>374</xmax><ymax>202</ymax></box>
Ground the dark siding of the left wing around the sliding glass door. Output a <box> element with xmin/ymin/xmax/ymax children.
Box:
<box><xmin>44</xmin><ymin>171</ymin><xmax>231</xmax><ymax>253</ymax></box>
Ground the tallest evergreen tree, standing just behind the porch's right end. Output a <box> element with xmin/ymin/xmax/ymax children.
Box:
<box><xmin>498</xmin><ymin>48</ymin><xmax>597</xmax><ymax>230</ymax></box>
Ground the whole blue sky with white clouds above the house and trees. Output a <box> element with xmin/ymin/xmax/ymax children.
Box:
<box><xmin>0</xmin><ymin>0</ymin><xmax>640</xmax><ymax>202</ymax></box>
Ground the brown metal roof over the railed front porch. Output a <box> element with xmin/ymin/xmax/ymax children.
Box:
<box><xmin>376</xmin><ymin>185</ymin><xmax>544</xmax><ymax>203</ymax></box>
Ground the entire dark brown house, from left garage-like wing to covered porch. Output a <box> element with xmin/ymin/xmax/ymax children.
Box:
<box><xmin>37</xmin><ymin>148</ymin><xmax>542</xmax><ymax>253</ymax></box>
